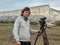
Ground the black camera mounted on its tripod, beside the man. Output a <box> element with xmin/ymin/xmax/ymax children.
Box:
<box><xmin>34</xmin><ymin>17</ymin><xmax>49</xmax><ymax>45</ymax></box>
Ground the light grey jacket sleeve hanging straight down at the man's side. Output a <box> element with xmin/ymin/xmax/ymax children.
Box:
<box><xmin>13</xmin><ymin>18</ymin><xmax>20</xmax><ymax>41</ymax></box>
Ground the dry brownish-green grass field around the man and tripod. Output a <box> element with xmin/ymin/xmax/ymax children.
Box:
<box><xmin>0</xmin><ymin>23</ymin><xmax>60</xmax><ymax>45</ymax></box>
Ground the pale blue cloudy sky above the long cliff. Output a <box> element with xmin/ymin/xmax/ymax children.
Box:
<box><xmin>0</xmin><ymin>0</ymin><xmax>60</xmax><ymax>11</ymax></box>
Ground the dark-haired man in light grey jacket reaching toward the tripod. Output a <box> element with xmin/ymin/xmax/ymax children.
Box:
<box><xmin>13</xmin><ymin>7</ymin><xmax>39</xmax><ymax>45</ymax></box>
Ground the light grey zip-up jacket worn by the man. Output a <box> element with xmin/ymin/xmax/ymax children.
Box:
<box><xmin>13</xmin><ymin>16</ymin><xmax>38</xmax><ymax>41</ymax></box>
